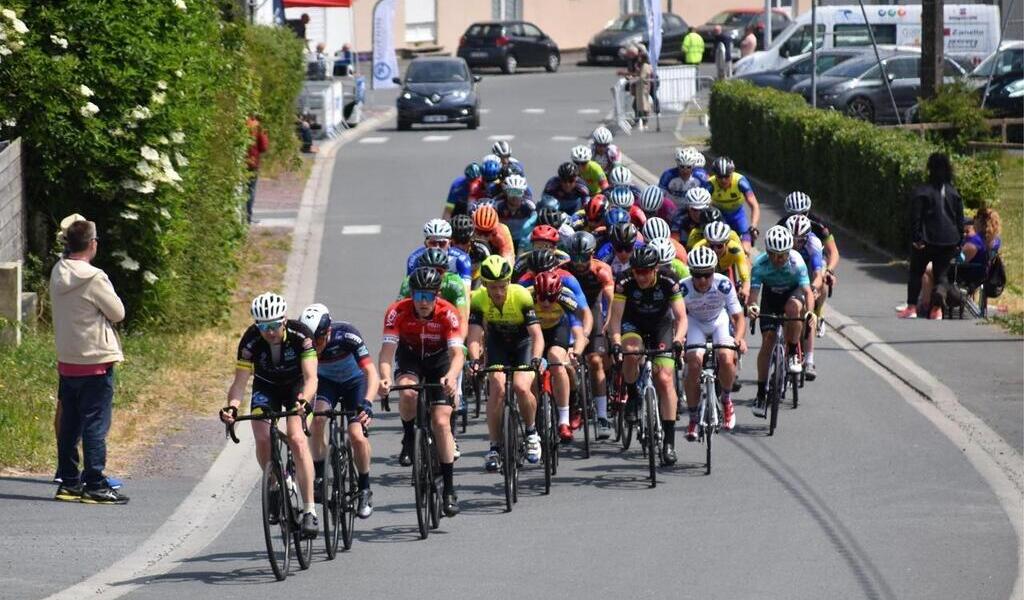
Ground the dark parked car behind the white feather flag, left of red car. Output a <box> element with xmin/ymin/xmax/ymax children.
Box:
<box><xmin>587</xmin><ymin>12</ymin><xmax>689</xmax><ymax>65</ymax></box>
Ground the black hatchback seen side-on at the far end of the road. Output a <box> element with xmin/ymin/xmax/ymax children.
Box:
<box><xmin>458</xmin><ymin>20</ymin><xmax>562</xmax><ymax>75</ymax></box>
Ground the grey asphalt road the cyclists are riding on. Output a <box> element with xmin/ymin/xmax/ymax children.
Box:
<box><xmin>14</xmin><ymin>64</ymin><xmax>1019</xmax><ymax>599</ymax></box>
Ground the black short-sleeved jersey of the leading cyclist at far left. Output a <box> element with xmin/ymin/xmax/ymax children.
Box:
<box><xmin>236</xmin><ymin>318</ymin><xmax>316</xmax><ymax>387</ymax></box>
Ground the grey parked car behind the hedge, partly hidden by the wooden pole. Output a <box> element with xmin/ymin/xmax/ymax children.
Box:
<box><xmin>793</xmin><ymin>51</ymin><xmax>966</xmax><ymax>123</ymax></box>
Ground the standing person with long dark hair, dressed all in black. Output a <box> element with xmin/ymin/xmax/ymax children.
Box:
<box><xmin>896</xmin><ymin>153</ymin><xmax>964</xmax><ymax>318</ymax></box>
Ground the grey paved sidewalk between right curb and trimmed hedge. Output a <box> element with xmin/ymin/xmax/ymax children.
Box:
<box><xmin>615</xmin><ymin>119</ymin><xmax>1024</xmax><ymax>453</ymax></box>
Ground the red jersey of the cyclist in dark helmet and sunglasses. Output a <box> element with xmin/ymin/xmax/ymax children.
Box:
<box><xmin>382</xmin><ymin>298</ymin><xmax>462</xmax><ymax>357</ymax></box>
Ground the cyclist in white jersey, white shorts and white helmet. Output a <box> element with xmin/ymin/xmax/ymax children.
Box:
<box><xmin>679</xmin><ymin>248</ymin><xmax>746</xmax><ymax>441</ymax></box>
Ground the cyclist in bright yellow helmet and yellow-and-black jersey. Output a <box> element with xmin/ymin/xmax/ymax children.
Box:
<box><xmin>469</xmin><ymin>255</ymin><xmax>546</xmax><ymax>472</ymax></box>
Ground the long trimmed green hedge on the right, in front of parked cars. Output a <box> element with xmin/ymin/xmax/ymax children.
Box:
<box><xmin>710</xmin><ymin>81</ymin><xmax>998</xmax><ymax>254</ymax></box>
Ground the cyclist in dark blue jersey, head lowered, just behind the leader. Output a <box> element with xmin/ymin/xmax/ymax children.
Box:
<box><xmin>299</xmin><ymin>303</ymin><xmax>380</xmax><ymax>519</ymax></box>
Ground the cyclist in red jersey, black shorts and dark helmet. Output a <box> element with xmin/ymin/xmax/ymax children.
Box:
<box><xmin>379</xmin><ymin>267</ymin><xmax>465</xmax><ymax>517</ymax></box>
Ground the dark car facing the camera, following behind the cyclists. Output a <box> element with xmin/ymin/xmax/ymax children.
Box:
<box><xmin>393</xmin><ymin>56</ymin><xmax>480</xmax><ymax>131</ymax></box>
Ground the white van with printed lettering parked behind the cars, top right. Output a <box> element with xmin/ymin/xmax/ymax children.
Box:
<box><xmin>732</xmin><ymin>4</ymin><xmax>999</xmax><ymax>75</ymax></box>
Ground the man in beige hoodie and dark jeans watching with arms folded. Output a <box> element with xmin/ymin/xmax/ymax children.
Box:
<box><xmin>50</xmin><ymin>220</ymin><xmax>128</xmax><ymax>504</ymax></box>
